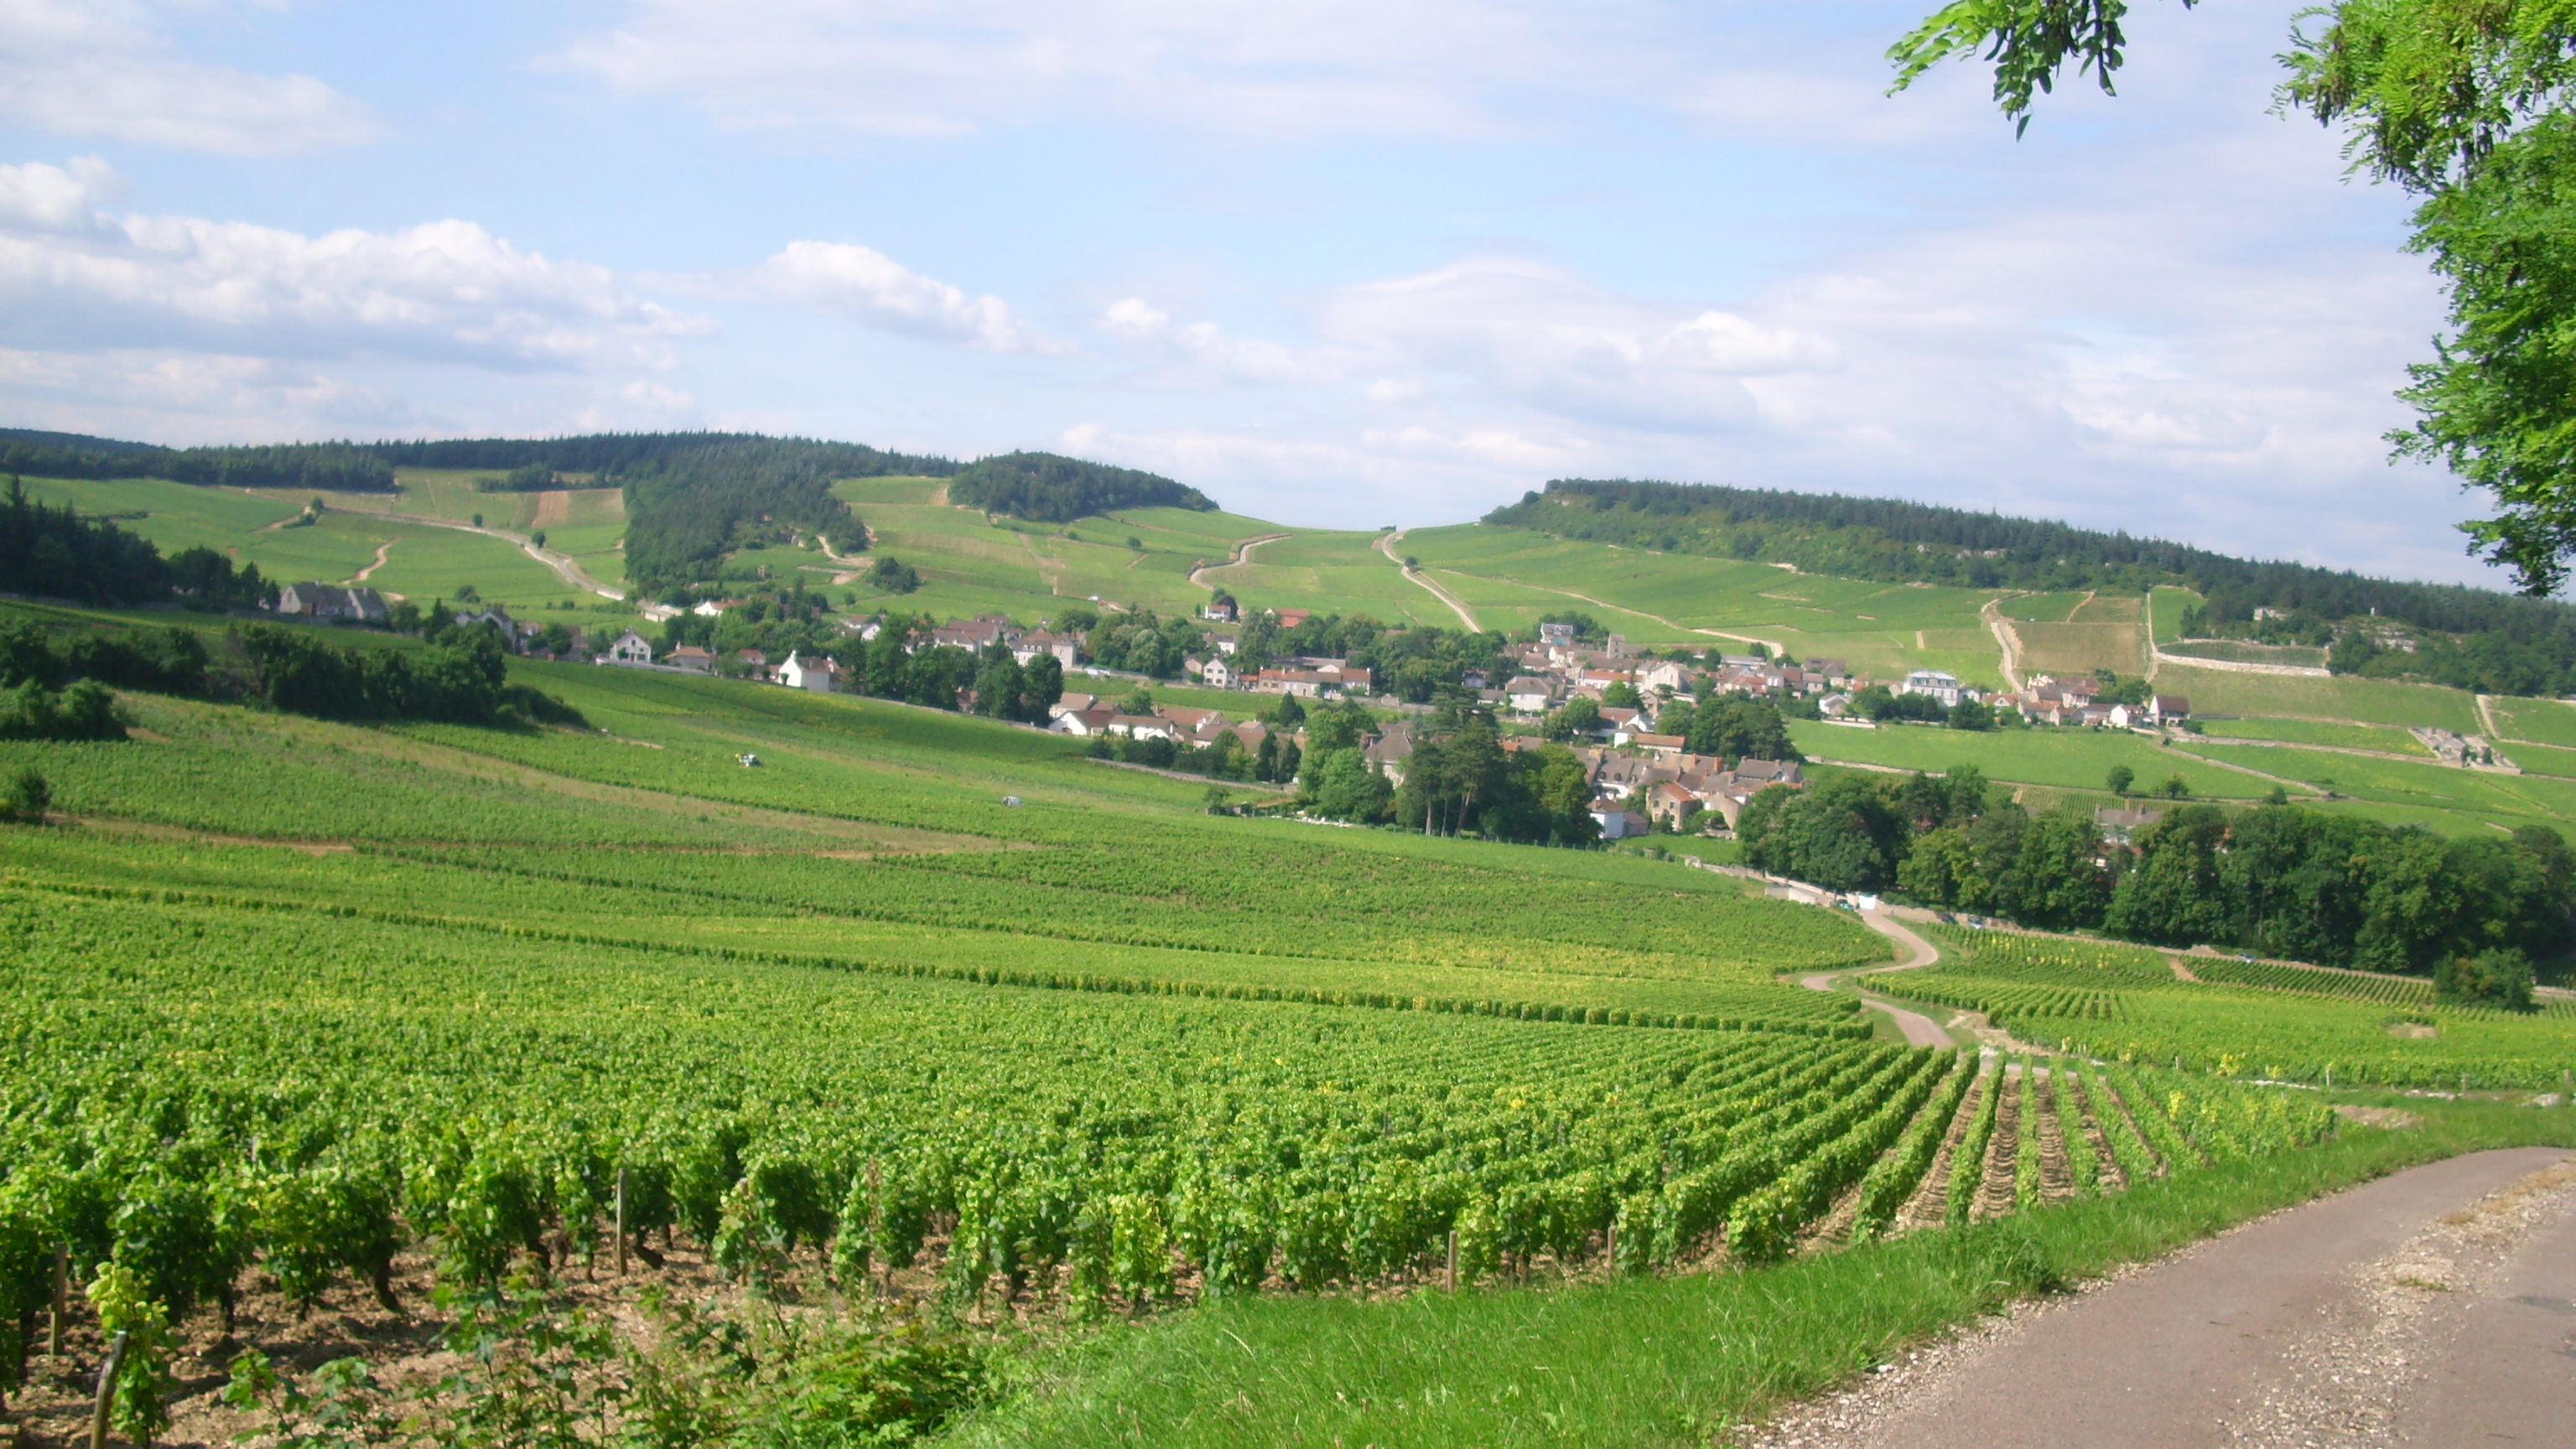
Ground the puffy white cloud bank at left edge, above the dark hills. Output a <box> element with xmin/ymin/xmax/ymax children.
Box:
<box><xmin>0</xmin><ymin>163</ymin><xmax>706</xmax><ymax>369</ymax></box>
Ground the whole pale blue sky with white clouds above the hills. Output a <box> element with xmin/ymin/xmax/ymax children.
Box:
<box><xmin>0</xmin><ymin>0</ymin><xmax>2504</xmax><ymax>585</ymax></box>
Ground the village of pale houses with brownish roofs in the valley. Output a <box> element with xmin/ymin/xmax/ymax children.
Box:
<box><xmin>261</xmin><ymin>583</ymin><xmax>2225</xmax><ymax>840</ymax></box>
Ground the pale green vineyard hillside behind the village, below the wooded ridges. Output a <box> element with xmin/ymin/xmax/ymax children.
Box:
<box><xmin>29</xmin><ymin>436</ymin><xmax>2576</xmax><ymax>833</ymax></box>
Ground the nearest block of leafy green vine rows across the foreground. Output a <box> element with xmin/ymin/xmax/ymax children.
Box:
<box><xmin>0</xmin><ymin>892</ymin><xmax>2326</xmax><ymax>1361</ymax></box>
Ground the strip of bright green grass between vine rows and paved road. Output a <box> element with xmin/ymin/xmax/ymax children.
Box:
<box><xmin>943</xmin><ymin>1104</ymin><xmax>2576</xmax><ymax>1449</ymax></box>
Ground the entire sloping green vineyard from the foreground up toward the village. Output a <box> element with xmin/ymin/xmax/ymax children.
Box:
<box><xmin>0</xmin><ymin>608</ymin><xmax>2514</xmax><ymax>1444</ymax></box>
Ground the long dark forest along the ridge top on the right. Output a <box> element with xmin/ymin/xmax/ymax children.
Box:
<box><xmin>1483</xmin><ymin>480</ymin><xmax>2576</xmax><ymax>693</ymax></box>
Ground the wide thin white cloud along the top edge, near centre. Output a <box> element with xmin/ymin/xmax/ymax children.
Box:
<box><xmin>564</xmin><ymin>0</ymin><xmax>1690</xmax><ymax>139</ymax></box>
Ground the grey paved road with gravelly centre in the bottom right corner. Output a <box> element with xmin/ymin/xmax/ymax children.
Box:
<box><xmin>1757</xmin><ymin>1147</ymin><xmax>2576</xmax><ymax>1449</ymax></box>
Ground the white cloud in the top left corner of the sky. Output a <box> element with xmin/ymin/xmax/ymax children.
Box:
<box><xmin>0</xmin><ymin>0</ymin><xmax>379</xmax><ymax>154</ymax></box>
